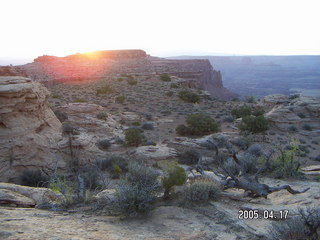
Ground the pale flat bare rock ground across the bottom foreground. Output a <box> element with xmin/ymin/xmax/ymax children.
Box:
<box><xmin>0</xmin><ymin>179</ymin><xmax>320</xmax><ymax>240</ymax></box>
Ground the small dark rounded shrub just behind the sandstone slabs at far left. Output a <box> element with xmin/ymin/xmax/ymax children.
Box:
<box><xmin>20</xmin><ymin>170</ymin><xmax>49</xmax><ymax>187</ymax></box>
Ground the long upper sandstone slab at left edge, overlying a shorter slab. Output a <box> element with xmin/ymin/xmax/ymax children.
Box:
<box><xmin>0</xmin><ymin>182</ymin><xmax>65</xmax><ymax>205</ymax></box>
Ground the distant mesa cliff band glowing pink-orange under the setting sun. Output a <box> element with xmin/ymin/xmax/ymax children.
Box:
<box><xmin>0</xmin><ymin>50</ymin><xmax>235</xmax><ymax>98</ymax></box>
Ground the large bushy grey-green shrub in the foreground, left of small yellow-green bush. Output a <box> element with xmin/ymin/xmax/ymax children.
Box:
<box><xmin>115</xmin><ymin>163</ymin><xmax>160</xmax><ymax>216</ymax></box>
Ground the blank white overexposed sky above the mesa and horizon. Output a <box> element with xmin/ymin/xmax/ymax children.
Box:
<box><xmin>0</xmin><ymin>0</ymin><xmax>320</xmax><ymax>62</ymax></box>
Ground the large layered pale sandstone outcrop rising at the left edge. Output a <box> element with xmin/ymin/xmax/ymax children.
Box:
<box><xmin>0</xmin><ymin>77</ymin><xmax>64</xmax><ymax>181</ymax></box>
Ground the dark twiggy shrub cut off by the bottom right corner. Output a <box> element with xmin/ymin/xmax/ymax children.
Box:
<box><xmin>269</xmin><ymin>207</ymin><xmax>320</xmax><ymax>240</ymax></box>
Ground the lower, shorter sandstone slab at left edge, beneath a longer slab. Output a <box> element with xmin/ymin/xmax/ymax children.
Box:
<box><xmin>0</xmin><ymin>189</ymin><xmax>36</xmax><ymax>207</ymax></box>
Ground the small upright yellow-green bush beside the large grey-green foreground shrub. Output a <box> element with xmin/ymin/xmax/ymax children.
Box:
<box><xmin>161</xmin><ymin>161</ymin><xmax>187</xmax><ymax>198</ymax></box>
